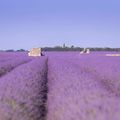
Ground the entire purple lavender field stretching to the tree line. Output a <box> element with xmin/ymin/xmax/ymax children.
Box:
<box><xmin>0</xmin><ymin>52</ymin><xmax>120</xmax><ymax>120</ymax></box>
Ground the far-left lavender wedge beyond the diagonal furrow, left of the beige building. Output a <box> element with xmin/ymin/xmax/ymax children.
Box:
<box><xmin>0</xmin><ymin>52</ymin><xmax>33</xmax><ymax>77</ymax></box>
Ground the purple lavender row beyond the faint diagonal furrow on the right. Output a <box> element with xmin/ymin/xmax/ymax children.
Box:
<box><xmin>74</xmin><ymin>53</ymin><xmax>120</xmax><ymax>96</ymax></box>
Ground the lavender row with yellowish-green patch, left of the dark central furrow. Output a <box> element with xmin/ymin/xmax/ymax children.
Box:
<box><xmin>0</xmin><ymin>57</ymin><xmax>47</xmax><ymax>120</ymax></box>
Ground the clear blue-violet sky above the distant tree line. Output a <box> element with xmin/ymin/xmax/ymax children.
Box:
<box><xmin>0</xmin><ymin>0</ymin><xmax>120</xmax><ymax>49</ymax></box>
